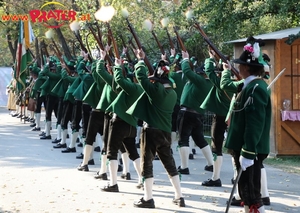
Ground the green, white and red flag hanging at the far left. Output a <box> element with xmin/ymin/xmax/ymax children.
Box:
<box><xmin>14</xmin><ymin>21</ymin><xmax>32</xmax><ymax>93</ymax></box>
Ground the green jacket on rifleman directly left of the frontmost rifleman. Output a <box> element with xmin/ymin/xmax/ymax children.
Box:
<box><xmin>106</xmin><ymin>63</ymin><xmax>143</xmax><ymax>127</ymax></box>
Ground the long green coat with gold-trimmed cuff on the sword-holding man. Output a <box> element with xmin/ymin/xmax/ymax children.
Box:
<box><xmin>225</xmin><ymin>78</ymin><xmax>271</xmax><ymax>159</ymax></box>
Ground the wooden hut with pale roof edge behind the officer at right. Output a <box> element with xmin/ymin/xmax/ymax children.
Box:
<box><xmin>228</xmin><ymin>27</ymin><xmax>300</xmax><ymax>156</ymax></box>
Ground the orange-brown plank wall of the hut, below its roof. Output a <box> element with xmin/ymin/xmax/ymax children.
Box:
<box><xmin>233</xmin><ymin>39</ymin><xmax>300</xmax><ymax>156</ymax></box>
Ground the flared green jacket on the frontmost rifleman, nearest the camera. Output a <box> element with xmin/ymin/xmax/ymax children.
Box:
<box><xmin>127</xmin><ymin>61</ymin><xmax>177</xmax><ymax>132</ymax></box>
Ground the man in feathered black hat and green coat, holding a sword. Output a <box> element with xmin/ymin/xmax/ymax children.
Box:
<box><xmin>225</xmin><ymin>38</ymin><xmax>271</xmax><ymax>213</ymax></box>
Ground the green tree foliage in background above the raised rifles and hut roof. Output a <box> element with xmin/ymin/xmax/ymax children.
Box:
<box><xmin>0</xmin><ymin>0</ymin><xmax>300</xmax><ymax>65</ymax></box>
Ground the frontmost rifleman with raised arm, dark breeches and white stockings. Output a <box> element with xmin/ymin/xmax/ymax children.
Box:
<box><xmin>127</xmin><ymin>49</ymin><xmax>185</xmax><ymax>208</ymax></box>
